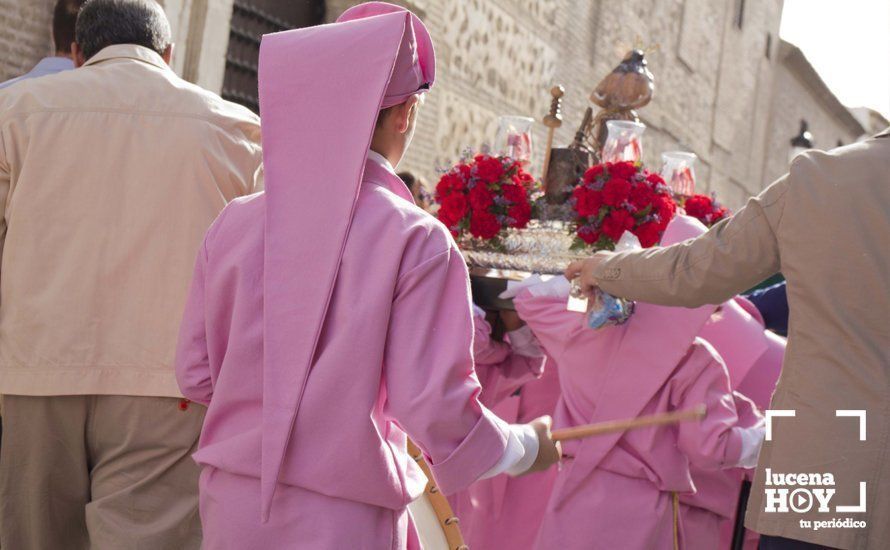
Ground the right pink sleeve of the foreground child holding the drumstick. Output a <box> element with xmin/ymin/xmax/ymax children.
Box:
<box><xmin>384</xmin><ymin>246</ymin><xmax>509</xmax><ymax>494</ymax></box>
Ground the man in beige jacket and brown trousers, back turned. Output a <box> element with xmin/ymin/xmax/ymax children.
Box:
<box><xmin>0</xmin><ymin>0</ymin><xmax>261</xmax><ymax>550</ymax></box>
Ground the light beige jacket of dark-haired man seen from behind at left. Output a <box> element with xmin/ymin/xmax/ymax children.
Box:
<box><xmin>0</xmin><ymin>45</ymin><xmax>262</xmax><ymax>396</ymax></box>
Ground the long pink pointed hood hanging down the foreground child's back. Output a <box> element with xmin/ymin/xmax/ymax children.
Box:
<box><xmin>259</xmin><ymin>2</ymin><xmax>435</xmax><ymax>521</ymax></box>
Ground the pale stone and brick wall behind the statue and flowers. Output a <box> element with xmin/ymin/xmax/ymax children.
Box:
<box><xmin>328</xmin><ymin>0</ymin><xmax>782</xmax><ymax>207</ymax></box>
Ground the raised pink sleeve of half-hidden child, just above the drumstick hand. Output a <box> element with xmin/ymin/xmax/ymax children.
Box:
<box><xmin>473</xmin><ymin>315</ymin><xmax>544</xmax><ymax>407</ymax></box>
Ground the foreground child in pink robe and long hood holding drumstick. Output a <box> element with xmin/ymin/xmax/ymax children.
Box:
<box><xmin>176</xmin><ymin>2</ymin><xmax>558</xmax><ymax>550</ymax></box>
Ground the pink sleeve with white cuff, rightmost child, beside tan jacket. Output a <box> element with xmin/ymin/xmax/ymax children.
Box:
<box><xmin>671</xmin><ymin>339</ymin><xmax>745</xmax><ymax>470</ymax></box>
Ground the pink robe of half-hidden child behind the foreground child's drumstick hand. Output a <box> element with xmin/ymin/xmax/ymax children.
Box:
<box><xmin>449</xmin><ymin>317</ymin><xmax>559</xmax><ymax>550</ymax></box>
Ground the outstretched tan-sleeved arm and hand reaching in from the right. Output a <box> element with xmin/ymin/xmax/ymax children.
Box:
<box><xmin>566</xmin><ymin>176</ymin><xmax>789</xmax><ymax>307</ymax></box>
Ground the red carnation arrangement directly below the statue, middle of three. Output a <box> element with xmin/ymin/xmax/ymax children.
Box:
<box><xmin>570</xmin><ymin>162</ymin><xmax>677</xmax><ymax>250</ymax></box>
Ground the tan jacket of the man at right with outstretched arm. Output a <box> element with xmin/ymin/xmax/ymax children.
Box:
<box><xmin>595</xmin><ymin>131</ymin><xmax>890</xmax><ymax>550</ymax></box>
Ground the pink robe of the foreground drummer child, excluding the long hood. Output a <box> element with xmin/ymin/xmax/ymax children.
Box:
<box><xmin>177</xmin><ymin>154</ymin><xmax>507</xmax><ymax>548</ymax></box>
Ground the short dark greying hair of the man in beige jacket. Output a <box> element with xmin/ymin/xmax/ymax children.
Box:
<box><xmin>75</xmin><ymin>0</ymin><xmax>170</xmax><ymax>59</ymax></box>
